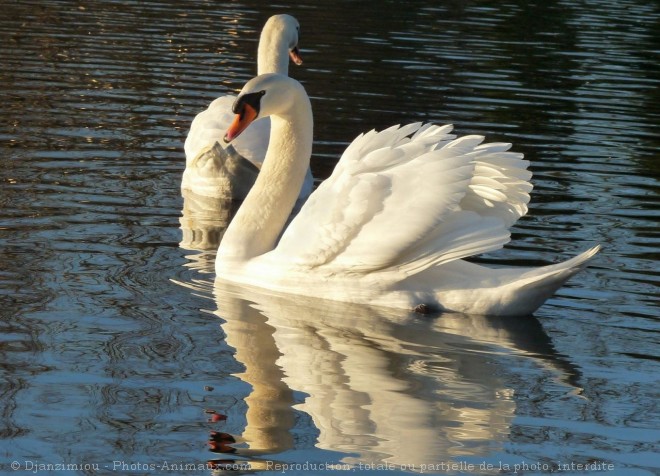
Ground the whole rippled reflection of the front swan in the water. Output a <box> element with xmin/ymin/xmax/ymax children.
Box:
<box><xmin>204</xmin><ymin>282</ymin><xmax>579</xmax><ymax>470</ymax></box>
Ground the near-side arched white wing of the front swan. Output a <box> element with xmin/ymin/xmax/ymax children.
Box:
<box><xmin>275</xmin><ymin>124</ymin><xmax>508</xmax><ymax>272</ymax></box>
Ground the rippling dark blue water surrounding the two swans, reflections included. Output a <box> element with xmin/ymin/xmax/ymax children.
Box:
<box><xmin>0</xmin><ymin>0</ymin><xmax>660</xmax><ymax>475</ymax></box>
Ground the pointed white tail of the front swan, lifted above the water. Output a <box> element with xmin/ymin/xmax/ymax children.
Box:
<box><xmin>508</xmin><ymin>245</ymin><xmax>600</xmax><ymax>315</ymax></box>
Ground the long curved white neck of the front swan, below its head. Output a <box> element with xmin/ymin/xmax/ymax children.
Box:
<box><xmin>216</xmin><ymin>87</ymin><xmax>313</xmax><ymax>266</ymax></box>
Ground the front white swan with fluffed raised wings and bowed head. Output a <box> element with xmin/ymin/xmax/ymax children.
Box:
<box><xmin>215</xmin><ymin>74</ymin><xmax>599</xmax><ymax>315</ymax></box>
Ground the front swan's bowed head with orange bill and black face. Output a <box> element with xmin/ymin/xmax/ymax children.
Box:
<box><xmin>224</xmin><ymin>73</ymin><xmax>307</xmax><ymax>142</ymax></box>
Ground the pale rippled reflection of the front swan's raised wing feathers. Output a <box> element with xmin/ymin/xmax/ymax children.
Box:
<box><xmin>269</xmin><ymin>309</ymin><xmax>515</xmax><ymax>465</ymax></box>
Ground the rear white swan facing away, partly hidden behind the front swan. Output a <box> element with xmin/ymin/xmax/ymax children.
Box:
<box><xmin>181</xmin><ymin>15</ymin><xmax>313</xmax><ymax>200</ymax></box>
